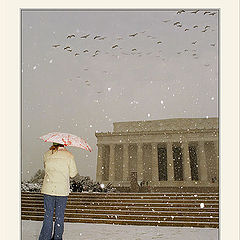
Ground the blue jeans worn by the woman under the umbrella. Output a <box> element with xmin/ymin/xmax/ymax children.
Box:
<box><xmin>38</xmin><ymin>194</ymin><xmax>67</xmax><ymax>240</ymax></box>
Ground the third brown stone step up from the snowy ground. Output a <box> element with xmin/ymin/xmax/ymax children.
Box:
<box><xmin>22</xmin><ymin>207</ymin><xmax>219</xmax><ymax>217</ymax></box>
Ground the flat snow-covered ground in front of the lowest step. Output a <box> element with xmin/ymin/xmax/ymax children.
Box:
<box><xmin>22</xmin><ymin>220</ymin><xmax>218</xmax><ymax>240</ymax></box>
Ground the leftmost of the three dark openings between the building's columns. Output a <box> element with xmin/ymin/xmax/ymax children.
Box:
<box><xmin>158</xmin><ymin>147</ymin><xmax>167</xmax><ymax>181</ymax></box>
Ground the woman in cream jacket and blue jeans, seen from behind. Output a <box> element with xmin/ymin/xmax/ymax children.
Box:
<box><xmin>39</xmin><ymin>143</ymin><xmax>77</xmax><ymax>240</ymax></box>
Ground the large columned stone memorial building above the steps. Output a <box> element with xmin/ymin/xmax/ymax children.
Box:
<box><xmin>96</xmin><ymin>118</ymin><xmax>219</xmax><ymax>190</ymax></box>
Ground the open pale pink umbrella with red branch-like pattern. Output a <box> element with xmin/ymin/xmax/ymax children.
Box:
<box><xmin>40</xmin><ymin>132</ymin><xmax>92</xmax><ymax>152</ymax></box>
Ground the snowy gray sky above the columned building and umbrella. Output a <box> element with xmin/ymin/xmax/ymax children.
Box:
<box><xmin>22</xmin><ymin>10</ymin><xmax>218</xmax><ymax>180</ymax></box>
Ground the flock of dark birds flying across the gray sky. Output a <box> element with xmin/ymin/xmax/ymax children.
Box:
<box><xmin>49</xmin><ymin>10</ymin><xmax>217</xmax><ymax>90</ymax></box>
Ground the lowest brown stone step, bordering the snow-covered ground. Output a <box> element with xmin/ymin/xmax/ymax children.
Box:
<box><xmin>22</xmin><ymin>215</ymin><xmax>218</xmax><ymax>228</ymax></box>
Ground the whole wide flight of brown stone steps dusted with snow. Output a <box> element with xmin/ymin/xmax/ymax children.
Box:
<box><xmin>22</xmin><ymin>192</ymin><xmax>219</xmax><ymax>228</ymax></box>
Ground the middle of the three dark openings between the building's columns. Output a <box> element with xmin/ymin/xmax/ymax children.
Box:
<box><xmin>173</xmin><ymin>146</ymin><xmax>183</xmax><ymax>181</ymax></box>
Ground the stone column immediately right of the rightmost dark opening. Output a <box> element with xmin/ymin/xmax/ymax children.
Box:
<box><xmin>198</xmin><ymin>141</ymin><xmax>208</xmax><ymax>182</ymax></box>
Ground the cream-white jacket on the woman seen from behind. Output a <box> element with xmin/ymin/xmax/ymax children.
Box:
<box><xmin>41</xmin><ymin>147</ymin><xmax>78</xmax><ymax>196</ymax></box>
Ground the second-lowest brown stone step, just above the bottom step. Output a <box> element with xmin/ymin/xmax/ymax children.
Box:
<box><xmin>22</xmin><ymin>211</ymin><xmax>219</xmax><ymax>222</ymax></box>
